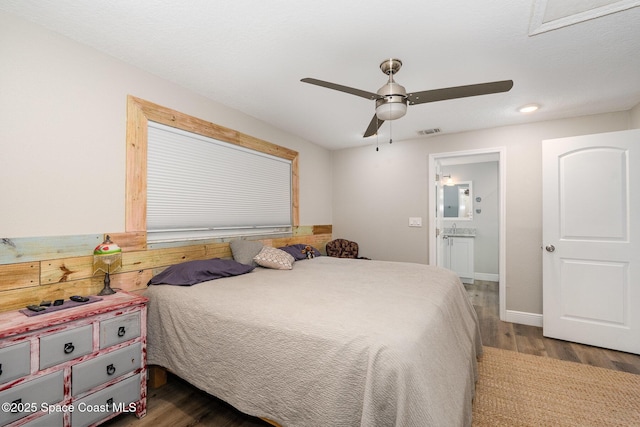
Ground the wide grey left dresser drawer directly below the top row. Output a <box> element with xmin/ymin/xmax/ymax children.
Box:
<box><xmin>0</xmin><ymin>371</ymin><xmax>64</xmax><ymax>426</ymax></box>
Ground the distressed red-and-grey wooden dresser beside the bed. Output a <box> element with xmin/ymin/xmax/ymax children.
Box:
<box><xmin>0</xmin><ymin>292</ymin><xmax>147</xmax><ymax>427</ymax></box>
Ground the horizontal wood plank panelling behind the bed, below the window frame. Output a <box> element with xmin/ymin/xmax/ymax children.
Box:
<box><xmin>0</xmin><ymin>225</ymin><xmax>332</xmax><ymax>312</ymax></box>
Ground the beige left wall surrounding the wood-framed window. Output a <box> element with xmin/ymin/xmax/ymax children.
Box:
<box><xmin>0</xmin><ymin>12</ymin><xmax>332</xmax><ymax>238</ymax></box>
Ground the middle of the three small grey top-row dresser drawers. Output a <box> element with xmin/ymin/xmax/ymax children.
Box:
<box><xmin>40</xmin><ymin>325</ymin><xmax>93</xmax><ymax>369</ymax></box>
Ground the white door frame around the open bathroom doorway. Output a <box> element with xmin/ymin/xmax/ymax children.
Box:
<box><xmin>428</xmin><ymin>147</ymin><xmax>507</xmax><ymax>321</ymax></box>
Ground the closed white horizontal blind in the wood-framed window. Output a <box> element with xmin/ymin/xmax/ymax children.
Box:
<box><xmin>147</xmin><ymin>121</ymin><xmax>292</xmax><ymax>242</ymax></box>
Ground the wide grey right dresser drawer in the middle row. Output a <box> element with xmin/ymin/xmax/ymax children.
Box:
<box><xmin>71</xmin><ymin>343</ymin><xmax>142</xmax><ymax>396</ymax></box>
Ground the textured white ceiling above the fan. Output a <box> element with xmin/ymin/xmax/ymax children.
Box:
<box><xmin>0</xmin><ymin>0</ymin><xmax>640</xmax><ymax>149</ymax></box>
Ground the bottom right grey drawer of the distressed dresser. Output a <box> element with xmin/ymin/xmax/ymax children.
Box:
<box><xmin>71</xmin><ymin>374</ymin><xmax>141</xmax><ymax>427</ymax></box>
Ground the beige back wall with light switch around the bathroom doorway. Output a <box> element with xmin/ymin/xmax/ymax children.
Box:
<box><xmin>333</xmin><ymin>111</ymin><xmax>631</xmax><ymax>314</ymax></box>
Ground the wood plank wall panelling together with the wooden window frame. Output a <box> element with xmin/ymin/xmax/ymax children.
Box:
<box><xmin>0</xmin><ymin>95</ymin><xmax>320</xmax><ymax>312</ymax></box>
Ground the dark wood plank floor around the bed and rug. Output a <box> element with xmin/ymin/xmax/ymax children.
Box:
<box><xmin>105</xmin><ymin>281</ymin><xmax>640</xmax><ymax>427</ymax></box>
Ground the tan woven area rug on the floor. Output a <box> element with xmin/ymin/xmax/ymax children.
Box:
<box><xmin>473</xmin><ymin>347</ymin><xmax>640</xmax><ymax>427</ymax></box>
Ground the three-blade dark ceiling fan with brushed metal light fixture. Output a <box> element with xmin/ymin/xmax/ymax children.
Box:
<box><xmin>301</xmin><ymin>58</ymin><xmax>513</xmax><ymax>138</ymax></box>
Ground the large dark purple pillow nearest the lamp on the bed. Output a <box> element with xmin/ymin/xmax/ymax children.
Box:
<box><xmin>147</xmin><ymin>258</ymin><xmax>255</xmax><ymax>286</ymax></box>
